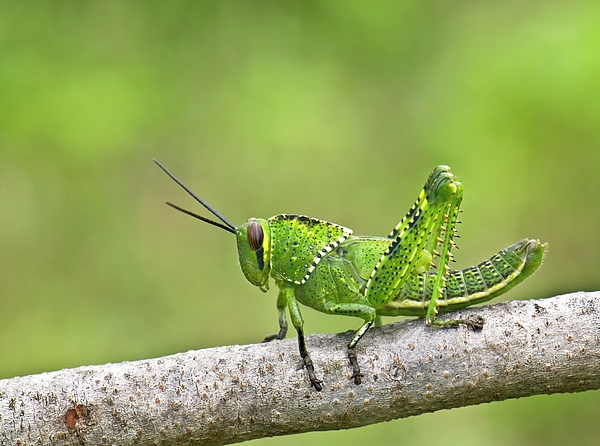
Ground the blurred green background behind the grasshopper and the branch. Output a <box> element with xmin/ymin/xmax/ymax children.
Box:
<box><xmin>0</xmin><ymin>0</ymin><xmax>600</xmax><ymax>445</ymax></box>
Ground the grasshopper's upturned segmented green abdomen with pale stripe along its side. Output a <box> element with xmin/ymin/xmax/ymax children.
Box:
<box><xmin>377</xmin><ymin>239</ymin><xmax>546</xmax><ymax>316</ymax></box>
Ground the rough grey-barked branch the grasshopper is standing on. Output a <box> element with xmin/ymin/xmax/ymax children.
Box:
<box><xmin>0</xmin><ymin>292</ymin><xmax>600</xmax><ymax>445</ymax></box>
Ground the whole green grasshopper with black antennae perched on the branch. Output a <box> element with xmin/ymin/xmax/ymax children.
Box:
<box><xmin>154</xmin><ymin>160</ymin><xmax>547</xmax><ymax>391</ymax></box>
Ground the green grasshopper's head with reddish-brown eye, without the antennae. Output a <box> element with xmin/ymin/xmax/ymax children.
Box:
<box><xmin>236</xmin><ymin>218</ymin><xmax>271</xmax><ymax>292</ymax></box>
